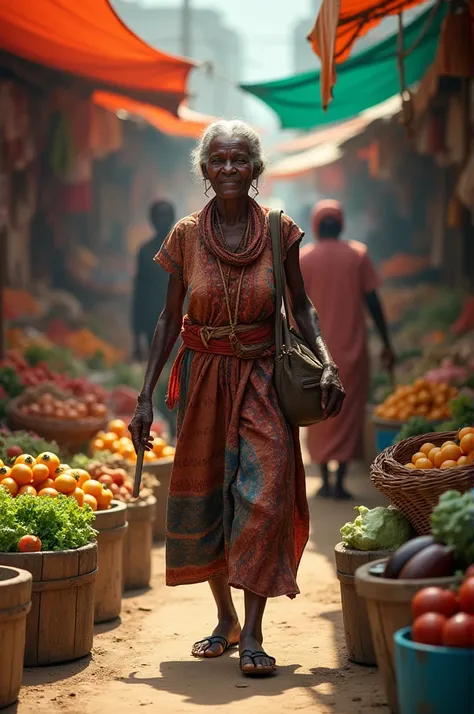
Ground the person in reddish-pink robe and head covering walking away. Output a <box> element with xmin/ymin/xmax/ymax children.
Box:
<box><xmin>301</xmin><ymin>196</ymin><xmax>395</xmax><ymax>499</ymax></box>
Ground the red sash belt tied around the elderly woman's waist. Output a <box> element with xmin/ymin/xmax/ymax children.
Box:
<box><xmin>166</xmin><ymin>315</ymin><xmax>275</xmax><ymax>409</ymax></box>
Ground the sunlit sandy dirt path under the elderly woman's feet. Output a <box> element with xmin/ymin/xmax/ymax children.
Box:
<box><xmin>9</xmin><ymin>468</ymin><xmax>388</xmax><ymax>714</ymax></box>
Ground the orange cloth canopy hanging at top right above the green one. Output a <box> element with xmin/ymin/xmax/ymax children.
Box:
<box><xmin>308</xmin><ymin>0</ymin><xmax>426</xmax><ymax>109</ymax></box>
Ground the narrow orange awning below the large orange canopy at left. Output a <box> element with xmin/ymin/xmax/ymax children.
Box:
<box><xmin>92</xmin><ymin>92</ymin><xmax>215</xmax><ymax>139</ymax></box>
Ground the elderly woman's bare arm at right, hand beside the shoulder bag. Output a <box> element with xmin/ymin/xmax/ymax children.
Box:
<box><xmin>285</xmin><ymin>243</ymin><xmax>344</xmax><ymax>417</ymax></box>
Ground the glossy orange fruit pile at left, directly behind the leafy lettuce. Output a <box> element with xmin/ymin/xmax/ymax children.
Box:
<box><xmin>0</xmin><ymin>452</ymin><xmax>114</xmax><ymax>511</ymax></box>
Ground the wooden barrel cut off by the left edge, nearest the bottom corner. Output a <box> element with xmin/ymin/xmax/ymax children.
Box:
<box><xmin>0</xmin><ymin>565</ymin><xmax>33</xmax><ymax>709</ymax></box>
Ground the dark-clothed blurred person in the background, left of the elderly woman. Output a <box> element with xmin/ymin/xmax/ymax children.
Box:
<box><xmin>132</xmin><ymin>201</ymin><xmax>175</xmax><ymax>361</ymax></box>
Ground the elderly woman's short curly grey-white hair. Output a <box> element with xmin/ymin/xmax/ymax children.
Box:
<box><xmin>191</xmin><ymin>119</ymin><xmax>267</xmax><ymax>179</ymax></box>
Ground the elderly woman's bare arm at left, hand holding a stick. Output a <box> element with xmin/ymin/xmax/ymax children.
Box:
<box><xmin>129</xmin><ymin>275</ymin><xmax>186</xmax><ymax>451</ymax></box>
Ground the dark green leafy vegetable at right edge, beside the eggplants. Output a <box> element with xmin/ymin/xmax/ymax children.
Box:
<box><xmin>431</xmin><ymin>491</ymin><xmax>474</xmax><ymax>566</ymax></box>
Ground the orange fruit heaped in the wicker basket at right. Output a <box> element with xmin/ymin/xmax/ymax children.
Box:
<box><xmin>405</xmin><ymin>426</ymin><xmax>474</xmax><ymax>471</ymax></box>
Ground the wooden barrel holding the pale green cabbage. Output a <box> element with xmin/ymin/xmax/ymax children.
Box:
<box><xmin>334</xmin><ymin>543</ymin><xmax>390</xmax><ymax>666</ymax></box>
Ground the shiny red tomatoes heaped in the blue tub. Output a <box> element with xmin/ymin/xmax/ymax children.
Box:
<box><xmin>411</xmin><ymin>565</ymin><xmax>474</xmax><ymax>649</ymax></box>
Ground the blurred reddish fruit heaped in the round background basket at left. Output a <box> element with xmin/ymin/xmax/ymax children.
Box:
<box><xmin>19</xmin><ymin>391</ymin><xmax>108</xmax><ymax>421</ymax></box>
